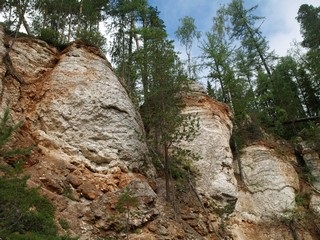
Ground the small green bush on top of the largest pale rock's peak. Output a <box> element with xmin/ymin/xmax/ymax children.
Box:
<box><xmin>76</xmin><ymin>30</ymin><xmax>106</xmax><ymax>50</ymax></box>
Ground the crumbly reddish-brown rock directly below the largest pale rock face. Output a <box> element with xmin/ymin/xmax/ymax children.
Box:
<box><xmin>26</xmin><ymin>157</ymin><xmax>159</xmax><ymax>240</ymax></box>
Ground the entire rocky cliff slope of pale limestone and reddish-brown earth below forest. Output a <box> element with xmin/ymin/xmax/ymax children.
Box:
<box><xmin>0</xmin><ymin>25</ymin><xmax>320</xmax><ymax>240</ymax></box>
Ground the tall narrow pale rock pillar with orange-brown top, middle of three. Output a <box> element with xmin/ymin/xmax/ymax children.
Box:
<box><xmin>183</xmin><ymin>84</ymin><xmax>238</xmax><ymax>204</ymax></box>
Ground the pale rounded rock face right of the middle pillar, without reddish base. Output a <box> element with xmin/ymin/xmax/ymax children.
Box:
<box><xmin>236</xmin><ymin>145</ymin><xmax>299</xmax><ymax>222</ymax></box>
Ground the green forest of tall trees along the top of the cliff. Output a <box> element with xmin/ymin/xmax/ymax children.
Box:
<box><xmin>0</xmin><ymin>0</ymin><xmax>320</xmax><ymax>150</ymax></box>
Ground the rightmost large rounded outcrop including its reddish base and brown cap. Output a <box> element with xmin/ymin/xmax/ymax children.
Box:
<box><xmin>229</xmin><ymin>141</ymin><xmax>316</xmax><ymax>240</ymax></box>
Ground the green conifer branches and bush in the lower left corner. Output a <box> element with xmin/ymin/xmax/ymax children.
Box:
<box><xmin>0</xmin><ymin>109</ymin><xmax>75</xmax><ymax>240</ymax></box>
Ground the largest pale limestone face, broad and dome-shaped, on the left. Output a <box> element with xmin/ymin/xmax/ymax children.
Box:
<box><xmin>34</xmin><ymin>45</ymin><xmax>152</xmax><ymax>171</ymax></box>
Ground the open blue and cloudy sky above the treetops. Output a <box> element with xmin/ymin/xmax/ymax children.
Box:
<box><xmin>149</xmin><ymin>0</ymin><xmax>320</xmax><ymax>58</ymax></box>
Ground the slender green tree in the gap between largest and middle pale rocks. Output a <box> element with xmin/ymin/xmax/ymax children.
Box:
<box><xmin>142</xmin><ymin>71</ymin><xmax>199</xmax><ymax>200</ymax></box>
